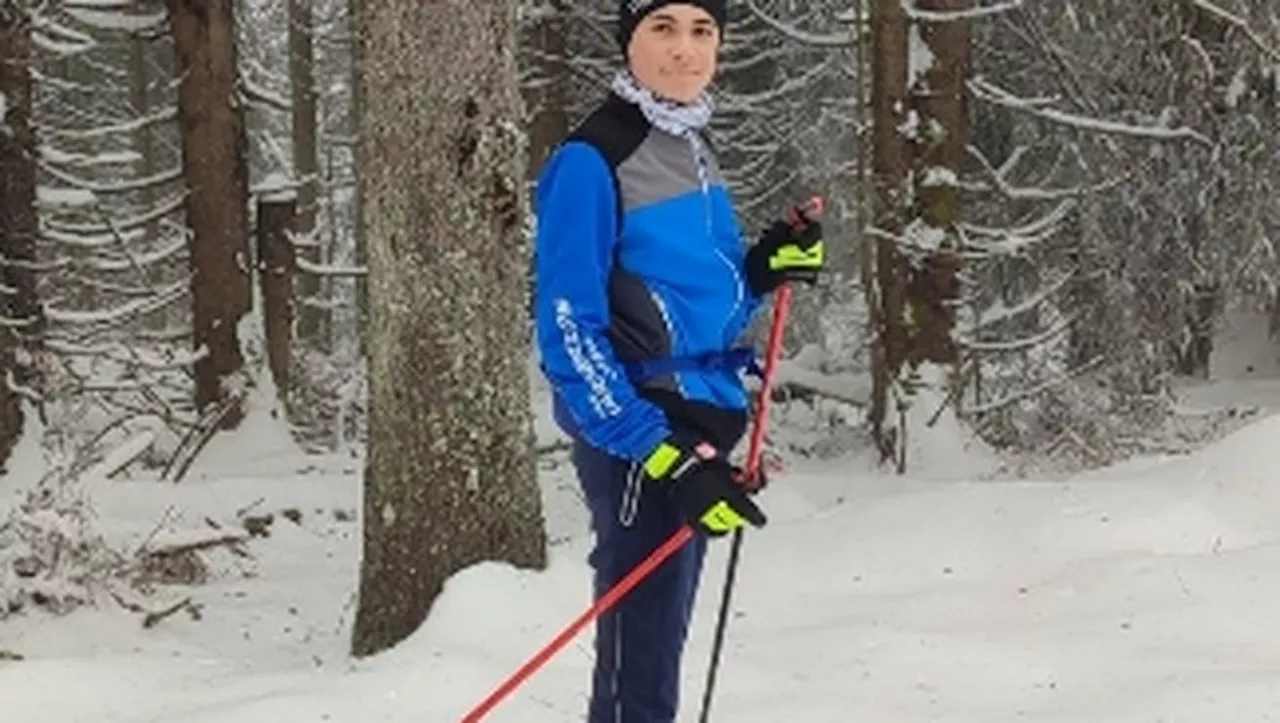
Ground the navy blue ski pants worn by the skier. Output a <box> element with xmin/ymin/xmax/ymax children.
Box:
<box><xmin>573</xmin><ymin>441</ymin><xmax>707</xmax><ymax>723</ymax></box>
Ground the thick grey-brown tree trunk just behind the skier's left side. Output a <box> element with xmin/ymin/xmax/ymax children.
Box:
<box><xmin>352</xmin><ymin>0</ymin><xmax>545</xmax><ymax>655</ymax></box>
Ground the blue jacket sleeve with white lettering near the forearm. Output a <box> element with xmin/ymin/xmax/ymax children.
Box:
<box><xmin>534</xmin><ymin>141</ymin><xmax>669</xmax><ymax>461</ymax></box>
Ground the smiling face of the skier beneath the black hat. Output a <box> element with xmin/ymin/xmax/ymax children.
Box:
<box><xmin>627</xmin><ymin>3</ymin><xmax>719</xmax><ymax>102</ymax></box>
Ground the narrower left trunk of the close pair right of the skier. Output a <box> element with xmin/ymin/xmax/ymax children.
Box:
<box><xmin>867</xmin><ymin>0</ymin><xmax>910</xmax><ymax>461</ymax></box>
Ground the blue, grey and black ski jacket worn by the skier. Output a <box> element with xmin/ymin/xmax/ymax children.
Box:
<box><xmin>534</xmin><ymin>95</ymin><xmax>760</xmax><ymax>461</ymax></box>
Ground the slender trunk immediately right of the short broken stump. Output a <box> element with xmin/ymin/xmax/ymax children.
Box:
<box><xmin>289</xmin><ymin>0</ymin><xmax>328</xmax><ymax>349</ymax></box>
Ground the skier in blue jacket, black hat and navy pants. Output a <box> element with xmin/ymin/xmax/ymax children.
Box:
<box><xmin>534</xmin><ymin>0</ymin><xmax>823</xmax><ymax>723</ymax></box>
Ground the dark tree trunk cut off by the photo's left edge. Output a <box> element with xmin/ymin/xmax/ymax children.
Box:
<box><xmin>0</xmin><ymin>5</ymin><xmax>41</xmax><ymax>463</ymax></box>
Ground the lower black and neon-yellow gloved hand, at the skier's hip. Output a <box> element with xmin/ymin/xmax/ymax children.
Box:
<box><xmin>644</xmin><ymin>433</ymin><xmax>765</xmax><ymax>537</ymax></box>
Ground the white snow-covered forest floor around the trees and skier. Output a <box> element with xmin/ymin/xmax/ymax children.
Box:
<box><xmin>0</xmin><ymin>317</ymin><xmax>1280</xmax><ymax>723</ymax></box>
